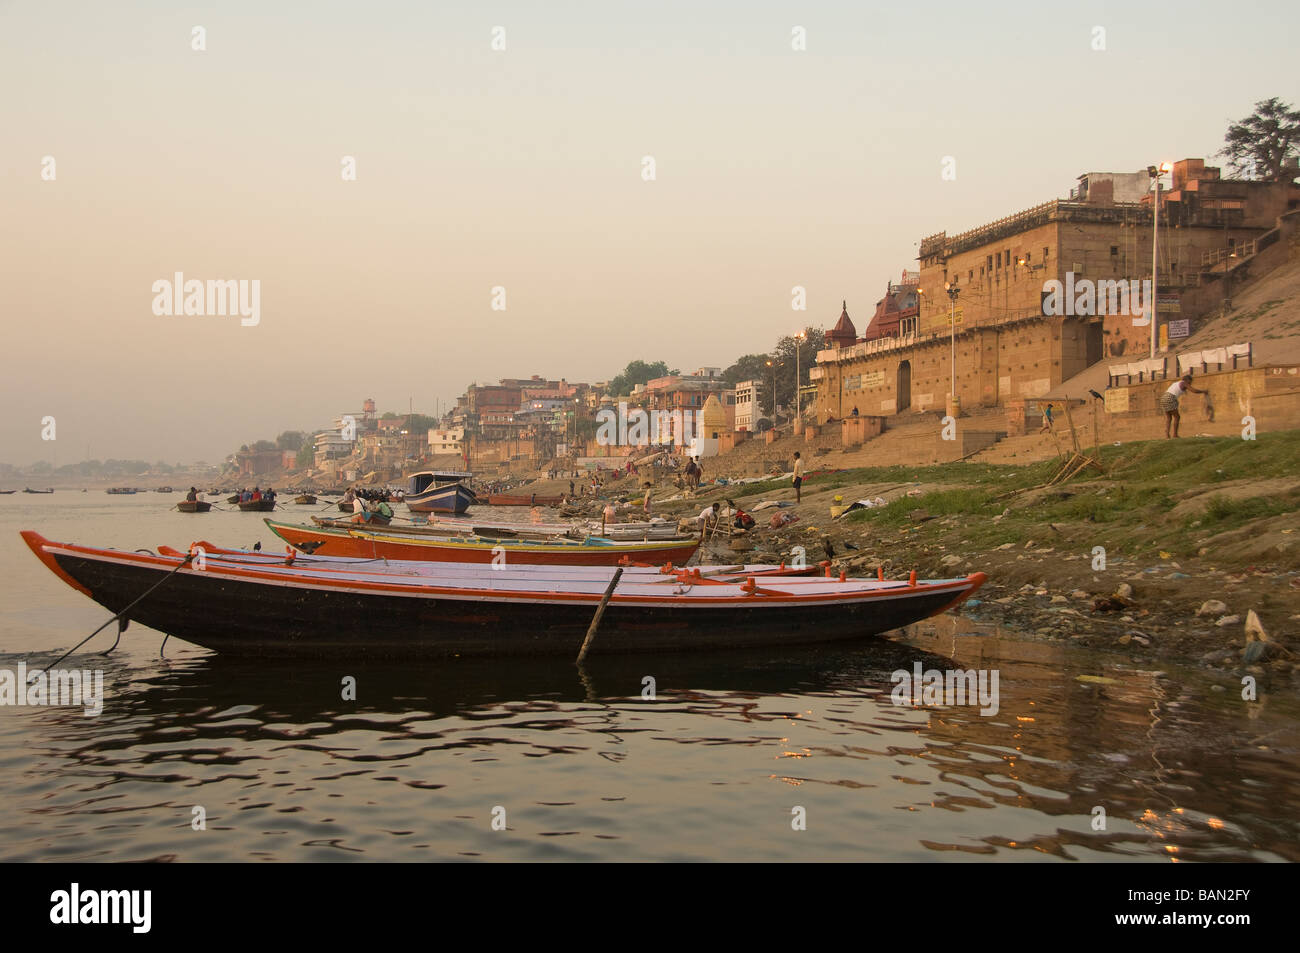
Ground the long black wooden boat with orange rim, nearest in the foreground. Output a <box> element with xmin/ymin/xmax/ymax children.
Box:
<box><xmin>22</xmin><ymin>530</ymin><xmax>985</xmax><ymax>658</ymax></box>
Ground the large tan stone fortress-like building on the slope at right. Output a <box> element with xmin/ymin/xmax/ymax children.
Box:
<box><xmin>811</xmin><ymin>159</ymin><xmax>1300</xmax><ymax>420</ymax></box>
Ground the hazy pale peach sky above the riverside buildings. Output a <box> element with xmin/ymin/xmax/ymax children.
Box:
<box><xmin>0</xmin><ymin>0</ymin><xmax>1300</xmax><ymax>464</ymax></box>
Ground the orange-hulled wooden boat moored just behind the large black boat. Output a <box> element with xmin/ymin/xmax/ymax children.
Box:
<box><xmin>267</xmin><ymin>520</ymin><xmax>699</xmax><ymax>566</ymax></box>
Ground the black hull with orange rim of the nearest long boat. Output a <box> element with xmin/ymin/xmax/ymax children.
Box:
<box><xmin>23</xmin><ymin>533</ymin><xmax>984</xmax><ymax>658</ymax></box>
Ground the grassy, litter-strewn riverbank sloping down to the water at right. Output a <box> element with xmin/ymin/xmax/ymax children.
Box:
<box><xmin>537</xmin><ymin>432</ymin><xmax>1300</xmax><ymax>676</ymax></box>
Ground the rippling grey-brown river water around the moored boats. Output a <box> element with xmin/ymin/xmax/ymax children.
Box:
<box><xmin>0</xmin><ymin>490</ymin><xmax>1300</xmax><ymax>862</ymax></box>
